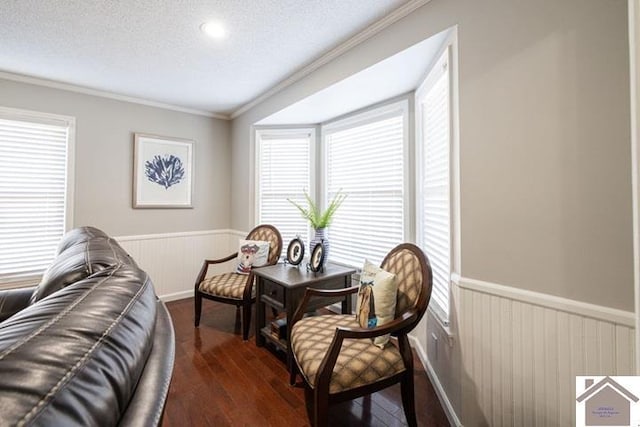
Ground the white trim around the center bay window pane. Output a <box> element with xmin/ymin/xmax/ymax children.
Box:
<box><xmin>317</xmin><ymin>99</ymin><xmax>414</xmax><ymax>268</ymax></box>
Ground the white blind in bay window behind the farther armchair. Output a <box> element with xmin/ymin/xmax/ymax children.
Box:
<box><xmin>256</xmin><ymin>130</ymin><xmax>315</xmax><ymax>246</ymax></box>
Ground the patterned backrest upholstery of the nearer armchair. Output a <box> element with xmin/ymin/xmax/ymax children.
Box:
<box><xmin>381</xmin><ymin>249</ymin><xmax>425</xmax><ymax>317</ymax></box>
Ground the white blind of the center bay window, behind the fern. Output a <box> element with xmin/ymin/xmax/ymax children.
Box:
<box><xmin>324</xmin><ymin>104</ymin><xmax>406</xmax><ymax>267</ymax></box>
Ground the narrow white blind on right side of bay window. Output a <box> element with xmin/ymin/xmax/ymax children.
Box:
<box><xmin>416</xmin><ymin>52</ymin><xmax>451</xmax><ymax>323</ymax></box>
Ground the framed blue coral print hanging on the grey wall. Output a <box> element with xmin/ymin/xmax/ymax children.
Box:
<box><xmin>133</xmin><ymin>133</ymin><xmax>193</xmax><ymax>208</ymax></box>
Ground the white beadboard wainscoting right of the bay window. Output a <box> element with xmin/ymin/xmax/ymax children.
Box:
<box><xmin>413</xmin><ymin>277</ymin><xmax>635</xmax><ymax>426</ymax></box>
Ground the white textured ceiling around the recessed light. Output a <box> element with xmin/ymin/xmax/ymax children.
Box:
<box><xmin>0</xmin><ymin>0</ymin><xmax>407</xmax><ymax>114</ymax></box>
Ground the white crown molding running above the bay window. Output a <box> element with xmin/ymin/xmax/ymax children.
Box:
<box><xmin>230</xmin><ymin>0</ymin><xmax>431</xmax><ymax>119</ymax></box>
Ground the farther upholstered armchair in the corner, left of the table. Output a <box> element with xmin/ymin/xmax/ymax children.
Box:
<box><xmin>194</xmin><ymin>224</ymin><xmax>282</xmax><ymax>341</ymax></box>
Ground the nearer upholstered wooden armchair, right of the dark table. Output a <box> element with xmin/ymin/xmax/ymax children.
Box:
<box><xmin>291</xmin><ymin>243</ymin><xmax>432</xmax><ymax>427</ymax></box>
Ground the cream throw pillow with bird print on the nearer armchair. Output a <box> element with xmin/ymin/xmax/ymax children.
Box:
<box><xmin>356</xmin><ymin>260</ymin><xmax>398</xmax><ymax>348</ymax></box>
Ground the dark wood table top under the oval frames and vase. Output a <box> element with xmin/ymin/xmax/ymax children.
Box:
<box><xmin>253</xmin><ymin>263</ymin><xmax>356</xmax><ymax>288</ymax></box>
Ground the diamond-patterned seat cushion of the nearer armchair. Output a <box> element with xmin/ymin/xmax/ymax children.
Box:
<box><xmin>291</xmin><ymin>315</ymin><xmax>405</xmax><ymax>394</ymax></box>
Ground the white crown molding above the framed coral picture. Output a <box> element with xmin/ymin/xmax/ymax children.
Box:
<box><xmin>0</xmin><ymin>71</ymin><xmax>230</xmax><ymax>120</ymax></box>
